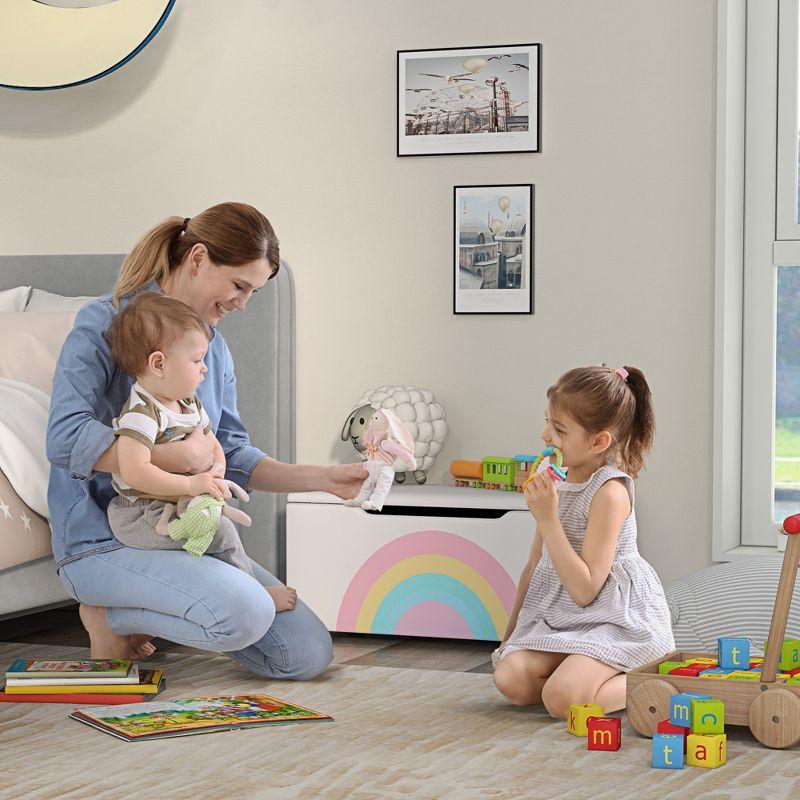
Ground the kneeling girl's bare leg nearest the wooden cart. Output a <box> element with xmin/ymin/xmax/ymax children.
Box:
<box><xmin>542</xmin><ymin>654</ymin><xmax>625</xmax><ymax>719</ymax></box>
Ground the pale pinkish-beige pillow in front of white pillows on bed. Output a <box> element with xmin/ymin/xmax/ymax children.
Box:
<box><xmin>0</xmin><ymin>311</ymin><xmax>75</xmax><ymax>395</ymax></box>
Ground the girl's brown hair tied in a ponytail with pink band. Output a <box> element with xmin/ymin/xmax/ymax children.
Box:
<box><xmin>547</xmin><ymin>366</ymin><xmax>655</xmax><ymax>478</ymax></box>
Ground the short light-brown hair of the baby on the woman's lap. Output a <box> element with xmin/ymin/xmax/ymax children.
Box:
<box><xmin>105</xmin><ymin>292</ymin><xmax>211</xmax><ymax>377</ymax></box>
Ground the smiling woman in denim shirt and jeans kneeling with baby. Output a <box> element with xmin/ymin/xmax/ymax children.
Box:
<box><xmin>47</xmin><ymin>203</ymin><xmax>366</xmax><ymax>679</ymax></box>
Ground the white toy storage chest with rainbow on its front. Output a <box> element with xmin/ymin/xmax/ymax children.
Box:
<box><xmin>286</xmin><ymin>485</ymin><xmax>536</xmax><ymax>641</ymax></box>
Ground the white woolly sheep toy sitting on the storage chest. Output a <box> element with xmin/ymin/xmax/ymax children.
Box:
<box><xmin>341</xmin><ymin>386</ymin><xmax>449</xmax><ymax>483</ymax></box>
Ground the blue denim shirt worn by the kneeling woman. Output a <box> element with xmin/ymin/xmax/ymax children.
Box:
<box><xmin>47</xmin><ymin>281</ymin><xmax>265</xmax><ymax>566</ymax></box>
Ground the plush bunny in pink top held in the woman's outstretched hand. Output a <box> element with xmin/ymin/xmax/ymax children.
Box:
<box><xmin>345</xmin><ymin>408</ymin><xmax>417</xmax><ymax>511</ymax></box>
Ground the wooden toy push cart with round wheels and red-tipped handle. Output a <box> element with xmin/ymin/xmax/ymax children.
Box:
<box><xmin>627</xmin><ymin>514</ymin><xmax>800</xmax><ymax>748</ymax></box>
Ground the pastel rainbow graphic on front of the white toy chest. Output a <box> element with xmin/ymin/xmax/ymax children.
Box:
<box><xmin>336</xmin><ymin>530</ymin><xmax>516</xmax><ymax>641</ymax></box>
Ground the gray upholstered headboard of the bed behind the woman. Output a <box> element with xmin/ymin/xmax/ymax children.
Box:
<box><xmin>0</xmin><ymin>255</ymin><xmax>295</xmax><ymax>577</ymax></box>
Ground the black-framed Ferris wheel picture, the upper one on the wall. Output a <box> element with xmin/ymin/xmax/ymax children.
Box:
<box><xmin>397</xmin><ymin>44</ymin><xmax>541</xmax><ymax>156</ymax></box>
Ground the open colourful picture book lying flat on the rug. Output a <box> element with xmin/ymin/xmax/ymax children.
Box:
<box><xmin>69</xmin><ymin>694</ymin><xmax>333</xmax><ymax>742</ymax></box>
